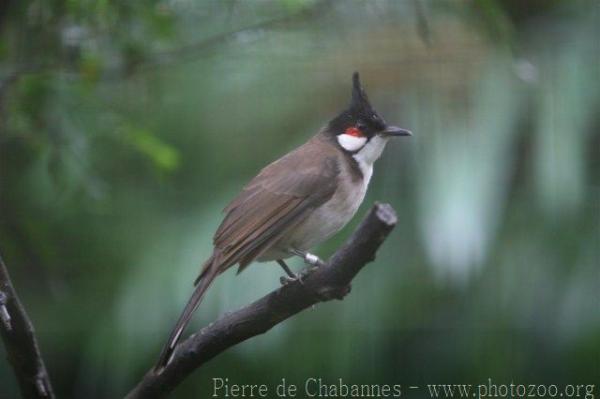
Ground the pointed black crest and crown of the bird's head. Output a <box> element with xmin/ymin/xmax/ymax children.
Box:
<box><xmin>328</xmin><ymin>72</ymin><xmax>385</xmax><ymax>135</ymax></box>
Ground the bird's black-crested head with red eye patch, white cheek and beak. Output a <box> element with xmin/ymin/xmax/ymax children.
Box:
<box><xmin>327</xmin><ymin>72</ymin><xmax>412</xmax><ymax>161</ymax></box>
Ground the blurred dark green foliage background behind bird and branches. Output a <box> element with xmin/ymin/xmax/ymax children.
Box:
<box><xmin>0</xmin><ymin>0</ymin><xmax>600</xmax><ymax>399</ymax></box>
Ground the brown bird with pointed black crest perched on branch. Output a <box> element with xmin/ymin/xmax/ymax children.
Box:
<box><xmin>154</xmin><ymin>72</ymin><xmax>412</xmax><ymax>372</ymax></box>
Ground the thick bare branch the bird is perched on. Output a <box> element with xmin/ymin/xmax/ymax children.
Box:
<box><xmin>126</xmin><ymin>204</ymin><xmax>396</xmax><ymax>399</ymax></box>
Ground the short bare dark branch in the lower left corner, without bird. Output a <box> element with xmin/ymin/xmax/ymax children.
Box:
<box><xmin>0</xmin><ymin>252</ymin><xmax>54</xmax><ymax>399</ymax></box>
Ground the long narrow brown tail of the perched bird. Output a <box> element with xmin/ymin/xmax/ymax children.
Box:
<box><xmin>154</xmin><ymin>255</ymin><xmax>219</xmax><ymax>372</ymax></box>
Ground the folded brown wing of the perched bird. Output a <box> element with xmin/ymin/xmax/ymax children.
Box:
<box><xmin>207</xmin><ymin>139</ymin><xmax>339</xmax><ymax>272</ymax></box>
